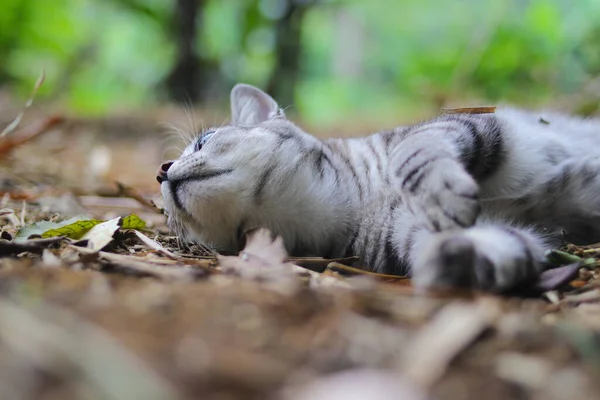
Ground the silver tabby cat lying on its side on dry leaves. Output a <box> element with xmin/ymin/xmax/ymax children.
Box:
<box><xmin>158</xmin><ymin>84</ymin><xmax>600</xmax><ymax>291</ymax></box>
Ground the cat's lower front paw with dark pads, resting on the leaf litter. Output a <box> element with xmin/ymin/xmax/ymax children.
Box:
<box><xmin>410</xmin><ymin>225</ymin><xmax>547</xmax><ymax>292</ymax></box>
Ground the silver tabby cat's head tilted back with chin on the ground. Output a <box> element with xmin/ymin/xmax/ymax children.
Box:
<box><xmin>157</xmin><ymin>84</ymin><xmax>342</xmax><ymax>252</ymax></box>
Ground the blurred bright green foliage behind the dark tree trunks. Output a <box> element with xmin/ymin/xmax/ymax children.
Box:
<box><xmin>0</xmin><ymin>0</ymin><xmax>600</xmax><ymax>123</ymax></box>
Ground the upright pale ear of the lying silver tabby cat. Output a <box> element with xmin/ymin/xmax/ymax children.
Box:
<box><xmin>231</xmin><ymin>83</ymin><xmax>282</xmax><ymax>125</ymax></box>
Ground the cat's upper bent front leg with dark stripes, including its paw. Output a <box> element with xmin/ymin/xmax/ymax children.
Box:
<box><xmin>389</xmin><ymin>115</ymin><xmax>506</xmax><ymax>232</ymax></box>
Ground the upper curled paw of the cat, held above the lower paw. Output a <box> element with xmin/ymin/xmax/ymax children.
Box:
<box><xmin>401</xmin><ymin>158</ymin><xmax>481</xmax><ymax>232</ymax></box>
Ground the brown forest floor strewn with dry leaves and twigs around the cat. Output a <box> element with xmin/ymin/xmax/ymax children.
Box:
<box><xmin>0</xmin><ymin>103</ymin><xmax>600</xmax><ymax>400</ymax></box>
